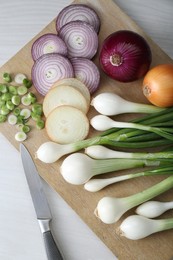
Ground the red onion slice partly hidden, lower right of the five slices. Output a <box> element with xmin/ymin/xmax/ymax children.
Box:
<box><xmin>71</xmin><ymin>58</ymin><xmax>100</xmax><ymax>94</ymax></box>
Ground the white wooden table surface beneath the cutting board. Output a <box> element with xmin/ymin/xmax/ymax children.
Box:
<box><xmin>0</xmin><ymin>0</ymin><xmax>173</xmax><ymax>260</ymax></box>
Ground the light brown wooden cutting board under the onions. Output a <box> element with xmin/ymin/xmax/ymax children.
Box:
<box><xmin>0</xmin><ymin>0</ymin><xmax>173</xmax><ymax>260</ymax></box>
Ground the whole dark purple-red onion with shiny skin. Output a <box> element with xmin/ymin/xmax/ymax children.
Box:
<box><xmin>99</xmin><ymin>30</ymin><xmax>152</xmax><ymax>82</ymax></box>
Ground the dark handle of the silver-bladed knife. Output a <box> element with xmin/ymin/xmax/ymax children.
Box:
<box><xmin>43</xmin><ymin>230</ymin><xmax>64</xmax><ymax>260</ymax></box>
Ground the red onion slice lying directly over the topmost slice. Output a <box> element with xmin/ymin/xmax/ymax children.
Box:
<box><xmin>59</xmin><ymin>21</ymin><xmax>98</xmax><ymax>59</ymax></box>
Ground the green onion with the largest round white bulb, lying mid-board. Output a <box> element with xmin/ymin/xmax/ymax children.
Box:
<box><xmin>60</xmin><ymin>153</ymin><xmax>172</xmax><ymax>185</ymax></box>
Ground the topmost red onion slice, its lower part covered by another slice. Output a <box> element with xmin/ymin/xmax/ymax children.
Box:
<box><xmin>56</xmin><ymin>4</ymin><xmax>100</xmax><ymax>33</ymax></box>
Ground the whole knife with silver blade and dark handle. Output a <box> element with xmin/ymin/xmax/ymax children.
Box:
<box><xmin>20</xmin><ymin>144</ymin><xmax>64</xmax><ymax>260</ymax></box>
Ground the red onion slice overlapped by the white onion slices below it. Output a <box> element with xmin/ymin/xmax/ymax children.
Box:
<box><xmin>31</xmin><ymin>53</ymin><xmax>74</xmax><ymax>96</ymax></box>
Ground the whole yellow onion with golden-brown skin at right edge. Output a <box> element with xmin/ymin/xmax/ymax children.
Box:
<box><xmin>142</xmin><ymin>64</ymin><xmax>173</xmax><ymax>107</ymax></box>
